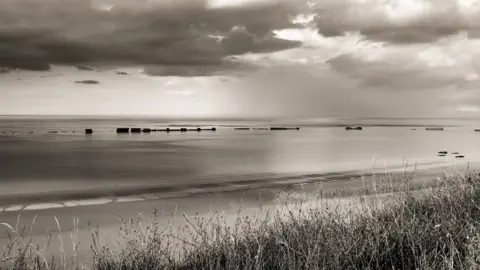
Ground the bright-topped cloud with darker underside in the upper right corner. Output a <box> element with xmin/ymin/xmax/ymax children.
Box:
<box><xmin>313</xmin><ymin>0</ymin><xmax>480</xmax><ymax>44</ymax></box>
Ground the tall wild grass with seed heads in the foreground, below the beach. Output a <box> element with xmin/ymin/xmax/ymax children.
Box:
<box><xmin>0</xmin><ymin>166</ymin><xmax>480</xmax><ymax>270</ymax></box>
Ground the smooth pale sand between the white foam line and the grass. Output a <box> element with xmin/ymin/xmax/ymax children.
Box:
<box><xmin>0</xmin><ymin>165</ymin><xmax>472</xmax><ymax>266</ymax></box>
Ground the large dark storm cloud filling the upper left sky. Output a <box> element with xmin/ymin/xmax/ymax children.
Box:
<box><xmin>0</xmin><ymin>0</ymin><xmax>300</xmax><ymax>75</ymax></box>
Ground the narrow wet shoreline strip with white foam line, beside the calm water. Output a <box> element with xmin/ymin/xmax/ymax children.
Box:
<box><xmin>0</xmin><ymin>162</ymin><xmax>462</xmax><ymax>213</ymax></box>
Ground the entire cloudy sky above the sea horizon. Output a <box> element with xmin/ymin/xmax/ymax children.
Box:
<box><xmin>0</xmin><ymin>0</ymin><xmax>480</xmax><ymax>118</ymax></box>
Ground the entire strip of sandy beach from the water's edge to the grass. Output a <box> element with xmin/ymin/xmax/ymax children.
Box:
<box><xmin>0</xmin><ymin>160</ymin><xmax>466</xmax><ymax>262</ymax></box>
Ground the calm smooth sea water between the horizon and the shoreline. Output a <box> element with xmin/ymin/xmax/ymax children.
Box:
<box><xmin>0</xmin><ymin>118</ymin><xmax>480</xmax><ymax>194</ymax></box>
